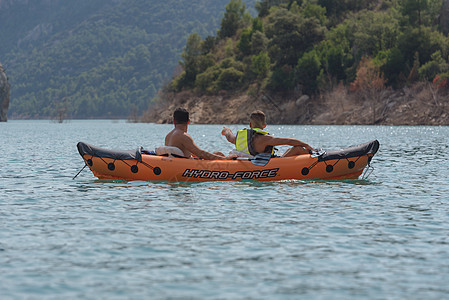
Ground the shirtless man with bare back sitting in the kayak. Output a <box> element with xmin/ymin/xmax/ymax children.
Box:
<box><xmin>165</xmin><ymin>108</ymin><xmax>233</xmax><ymax>160</ymax></box>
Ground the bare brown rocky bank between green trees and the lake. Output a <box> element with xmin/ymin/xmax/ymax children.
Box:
<box><xmin>142</xmin><ymin>82</ymin><xmax>449</xmax><ymax>125</ymax></box>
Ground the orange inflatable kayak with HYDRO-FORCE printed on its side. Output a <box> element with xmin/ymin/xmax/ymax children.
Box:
<box><xmin>75</xmin><ymin>140</ymin><xmax>379</xmax><ymax>181</ymax></box>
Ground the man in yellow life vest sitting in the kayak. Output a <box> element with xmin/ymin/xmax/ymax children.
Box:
<box><xmin>221</xmin><ymin>110</ymin><xmax>315</xmax><ymax>157</ymax></box>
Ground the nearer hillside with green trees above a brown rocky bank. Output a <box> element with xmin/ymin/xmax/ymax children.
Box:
<box><xmin>144</xmin><ymin>0</ymin><xmax>449</xmax><ymax>125</ymax></box>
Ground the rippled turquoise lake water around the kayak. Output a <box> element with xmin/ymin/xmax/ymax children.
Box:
<box><xmin>0</xmin><ymin>120</ymin><xmax>449</xmax><ymax>299</ymax></box>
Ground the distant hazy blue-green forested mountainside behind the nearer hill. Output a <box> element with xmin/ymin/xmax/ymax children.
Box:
<box><xmin>0</xmin><ymin>0</ymin><xmax>255</xmax><ymax>119</ymax></box>
